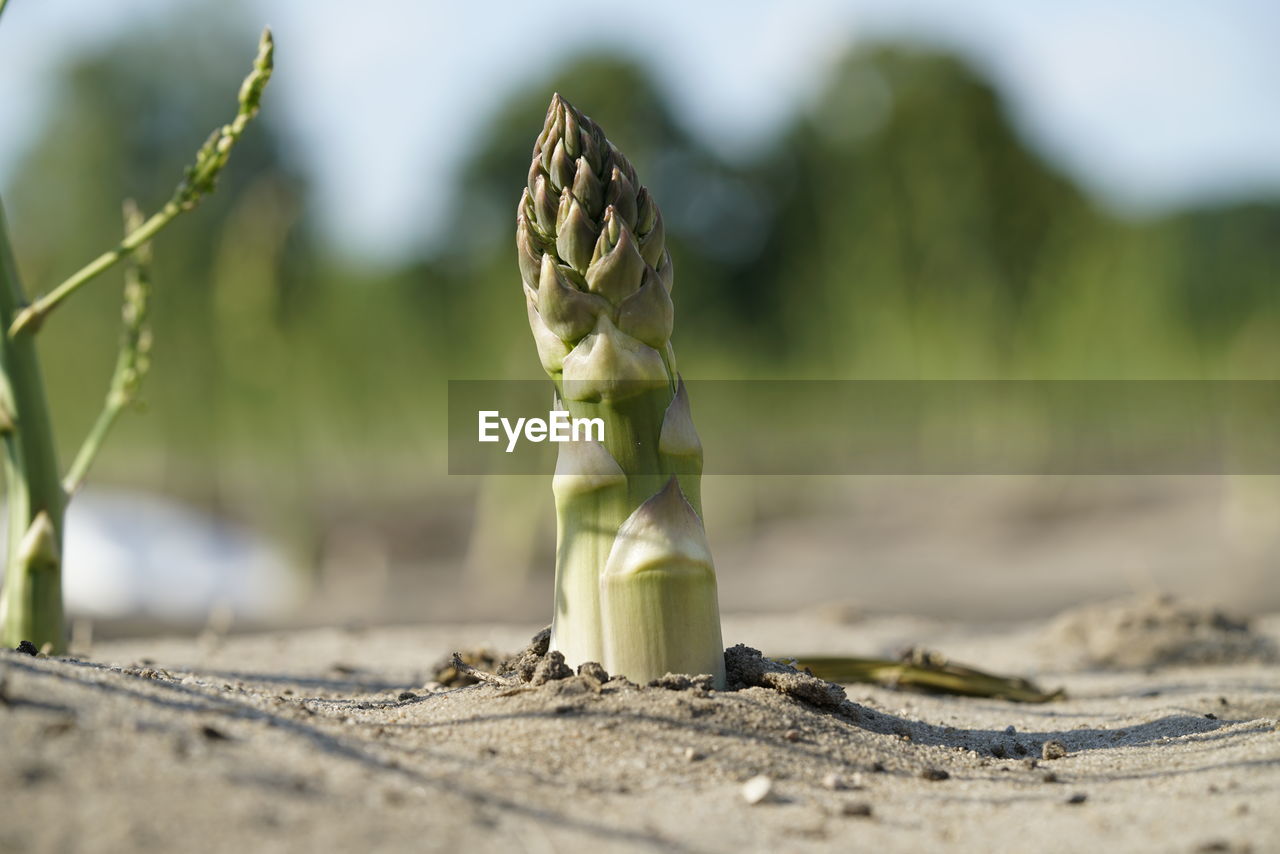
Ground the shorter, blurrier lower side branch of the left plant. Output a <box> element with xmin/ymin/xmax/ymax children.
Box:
<box><xmin>63</xmin><ymin>201</ymin><xmax>151</xmax><ymax>497</ymax></box>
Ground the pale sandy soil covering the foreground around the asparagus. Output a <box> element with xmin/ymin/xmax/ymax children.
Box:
<box><xmin>0</xmin><ymin>603</ymin><xmax>1280</xmax><ymax>851</ymax></box>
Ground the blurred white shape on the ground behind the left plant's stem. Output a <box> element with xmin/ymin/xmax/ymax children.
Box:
<box><xmin>0</xmin><ymin>489</ymin><xmax>301</xmax><ymax>621</ymax></box>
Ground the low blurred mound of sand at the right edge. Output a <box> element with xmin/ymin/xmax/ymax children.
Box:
<box><xmin>1039</xmin><ymin>597</ymin><xmax>1280</xmax><ymax>670</ymax></box>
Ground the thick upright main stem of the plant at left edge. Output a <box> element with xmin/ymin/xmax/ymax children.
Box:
<box><xmin>0</xmin><ymin>203</ymin><xmax>67</xmax><ymax>652</ymax></box>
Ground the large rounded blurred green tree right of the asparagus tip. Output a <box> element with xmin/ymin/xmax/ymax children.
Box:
<box><xmin>755</xmin><ymin>47</ymin><xmax>1096</xmax><ymax>376</ymax></box>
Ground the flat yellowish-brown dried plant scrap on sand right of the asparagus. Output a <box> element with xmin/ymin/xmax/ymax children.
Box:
<box><xmin>796</xmin><ymin>647</ymin><xmax>1065</xmax><ymax>703</ymax></box>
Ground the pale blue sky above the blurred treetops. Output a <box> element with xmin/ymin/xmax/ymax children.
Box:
<box><xmin>0</xmin><ymin>0</ymin><xmax>1280</xmax><ymax>261</ymax></box>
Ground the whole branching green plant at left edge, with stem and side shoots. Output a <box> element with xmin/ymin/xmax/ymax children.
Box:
<box><xmin>0</xmin><ymin>11</ymin><xmax>274</xmax><ymax>652</ymax></box>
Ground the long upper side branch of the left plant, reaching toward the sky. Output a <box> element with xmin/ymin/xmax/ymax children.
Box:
<box><xmin>6</xmin><ymin>29</ymin><xmax>275</xmax><ymax>337</ymax></box>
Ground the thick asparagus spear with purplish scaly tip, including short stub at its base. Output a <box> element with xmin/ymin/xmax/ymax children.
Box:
<box><xmin>516</xmin><ymin>95</ymin><xmax>724</xmax><ymax>684</ymax></box>
